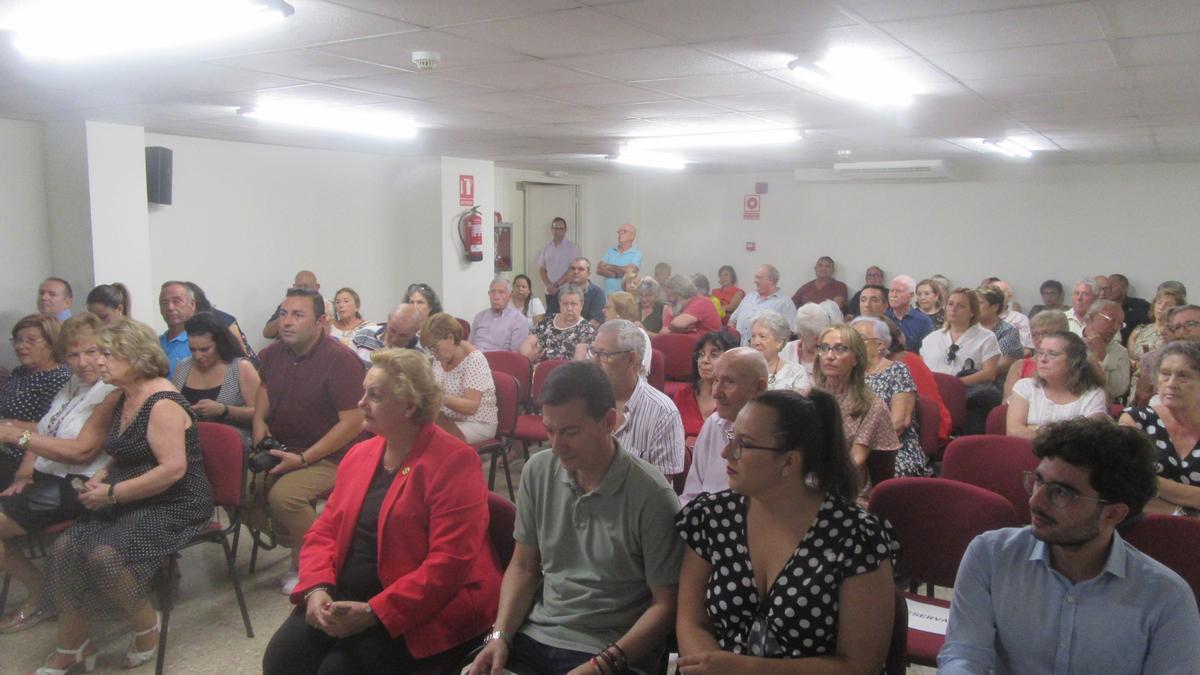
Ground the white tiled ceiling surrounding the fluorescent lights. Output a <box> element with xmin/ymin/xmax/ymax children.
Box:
<box><xmin>0</xmin><ymin>0</ymin><xmax>1200</xmax><ymax>171</ymax></box>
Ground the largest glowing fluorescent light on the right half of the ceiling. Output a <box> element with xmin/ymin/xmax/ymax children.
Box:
<box><xmin>787</xmin><ymin>47</ymin><xmax>917</xmax><ymax>107</ymax></box>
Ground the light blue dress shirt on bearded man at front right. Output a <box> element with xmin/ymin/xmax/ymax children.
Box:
<box><xmin>937</xmin><ymin>527</ymin><xmax>1200</xmax><ymax>675</ymax></box>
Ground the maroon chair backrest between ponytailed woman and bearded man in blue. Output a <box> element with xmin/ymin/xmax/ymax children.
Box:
<box><xmin>866</xmin><ymin>478</ymin><xmax>1018</xmax><ymax>587</ymax></box>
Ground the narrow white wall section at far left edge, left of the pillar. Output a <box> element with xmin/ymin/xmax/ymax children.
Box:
<box><xmin>0</xmin><ymin>119</ymin><xmax>52</xmax><ymax>368</ymax></box>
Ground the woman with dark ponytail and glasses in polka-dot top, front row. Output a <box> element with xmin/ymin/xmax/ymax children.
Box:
<box><xmin>676</xmin><ymin>390</ymin><xmax>899</xmax><ymax>675</ymax></box>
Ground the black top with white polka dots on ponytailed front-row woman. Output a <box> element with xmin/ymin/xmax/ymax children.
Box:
<box><xmin>676</xmin><ymin>490</ymin><xmax>900</xmax><ymax>658</ymax></box>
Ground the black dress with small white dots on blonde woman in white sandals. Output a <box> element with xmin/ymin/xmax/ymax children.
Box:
<box><xmin>46</xmin><ymin>392</ymin><xmax>212</xmax><ymax>620</ymax></box>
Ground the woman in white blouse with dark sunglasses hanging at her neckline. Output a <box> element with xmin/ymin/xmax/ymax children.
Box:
<box><xmin>920</xmin><ymin>288</ymin><xmax>1001</xmax><ymax>434</ymax></box>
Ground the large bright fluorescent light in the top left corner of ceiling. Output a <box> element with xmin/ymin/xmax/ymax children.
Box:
<box><xmin>12</xmin><ymin>0</ymin><xmax>295</xmax><ymax>61</ymax></box>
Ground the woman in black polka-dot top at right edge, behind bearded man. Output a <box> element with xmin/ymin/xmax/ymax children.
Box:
<box><xmin>1121</xmin><ymin>339</ymin><xmax>1200</xmax><ymax>515</ymax></box>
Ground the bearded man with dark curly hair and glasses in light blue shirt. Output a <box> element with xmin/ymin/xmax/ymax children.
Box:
<box><xmin>937</xmin><ymin>418</ymin><xmax>1200</xmax><ymax>675</ymax></box>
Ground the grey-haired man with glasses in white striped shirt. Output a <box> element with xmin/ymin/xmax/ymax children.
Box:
<box><xmin>589</xmin><ymin>318</ymin><xmax>684</xmax><ymax>479</ymax></box>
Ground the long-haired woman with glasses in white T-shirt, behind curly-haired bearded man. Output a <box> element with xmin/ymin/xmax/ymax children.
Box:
<box><xmin>1007</xmin><ymin>329</ymin><xmax>1109</xmax><ymax>438</ymax></box>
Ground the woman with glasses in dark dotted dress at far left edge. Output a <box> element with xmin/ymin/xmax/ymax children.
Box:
<box><xmin>0</xmin><ymin>313</ymin><xmax>71</xmax><ymax>490</ymax></box>
